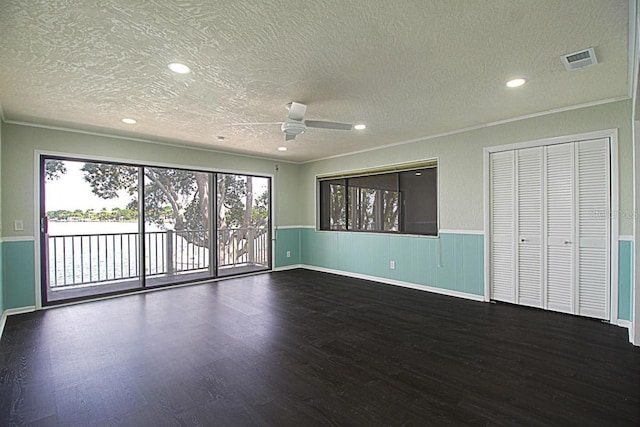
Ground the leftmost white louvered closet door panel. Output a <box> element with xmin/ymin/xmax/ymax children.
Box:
<box><xmin>489</xmin><ymin>151</ymin><xmax>516</xmax><ymax>302</ymax></box>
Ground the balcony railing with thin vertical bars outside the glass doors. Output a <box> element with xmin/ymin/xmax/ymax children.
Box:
<box><xmin>47</xmin><ymin>228</ymin><xmax>269</xmax><ymax>289</ymax></box>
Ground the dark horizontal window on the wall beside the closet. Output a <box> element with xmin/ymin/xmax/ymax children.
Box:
<box><xmin>319</xmin><ymin>162</ymin><xmax>438</xmax><ymax>236</ymax></box>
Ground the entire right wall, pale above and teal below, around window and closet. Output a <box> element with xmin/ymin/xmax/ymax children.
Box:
<box><xmin>292</xmin><ymin>100</ymin><xmax>633</xmax><ymax>318</ymax></box>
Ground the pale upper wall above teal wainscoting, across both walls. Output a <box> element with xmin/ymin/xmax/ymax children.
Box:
<box><xmin>0</xmin><ymin>100</ymin><xmax>640</xmax><ymax>343</ymax></box>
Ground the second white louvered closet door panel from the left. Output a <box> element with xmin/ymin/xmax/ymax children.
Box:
<box><xmin>516</xmin><ymin>147</ymin><xmax>544</xmax><ymax>307</ymax></box>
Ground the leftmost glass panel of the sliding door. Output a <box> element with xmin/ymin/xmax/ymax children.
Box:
<box><xmin>41</xmin><ymin>159</ymin><xmax>141</xmax><ymax>301</ymax></box>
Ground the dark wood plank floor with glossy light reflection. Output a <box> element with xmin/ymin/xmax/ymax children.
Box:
<box><xmin>0</xmin><ymin>270</ymin><xmax>640</xmax><ymax>426</ymax></box>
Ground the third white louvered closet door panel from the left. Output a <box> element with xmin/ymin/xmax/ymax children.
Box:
<box><xmin>545</xmin><ymin>143</ymin><xmax>575</xmax><ymax>313</ymax></box>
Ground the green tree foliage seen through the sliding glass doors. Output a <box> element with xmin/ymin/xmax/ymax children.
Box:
<box><xmin>47</xmin><ymin>161</ymin><xmax>269</xmax><ymax>257</ymax></box>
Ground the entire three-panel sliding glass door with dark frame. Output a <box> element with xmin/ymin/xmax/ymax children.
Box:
<box><xmin>41</xmin><ymin>157</ymin><xmax>271</xmax><ymax>305</ymax></box>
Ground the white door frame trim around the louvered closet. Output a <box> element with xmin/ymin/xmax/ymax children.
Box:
<box><xmin>483</xmin><ymin>129</ymin><xmax>620</xmax><ymax>324</ymax></box>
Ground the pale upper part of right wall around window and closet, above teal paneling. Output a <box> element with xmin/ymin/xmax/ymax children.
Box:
<box><xmin>298</xmin><ymin>100</ymin><xmax>633</xmax><ymax>235</ymax></box>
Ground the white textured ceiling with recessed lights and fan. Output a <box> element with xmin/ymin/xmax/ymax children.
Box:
<box><xmin>0</xmin><ymin>0</ymin><xmax>629</xmax><ymax>161</ymax></box>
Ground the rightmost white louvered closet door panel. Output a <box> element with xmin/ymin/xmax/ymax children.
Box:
<box><xmin>574</xmin><ymin>139</ymin><xmax>610</xmax><ymax>319</ymax></box>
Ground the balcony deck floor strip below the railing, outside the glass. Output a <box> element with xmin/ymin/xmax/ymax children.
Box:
<box><xmin>47</xmin><ymin>264</ymin><xmax>269</xmax><ymax>302</ymax></box>
